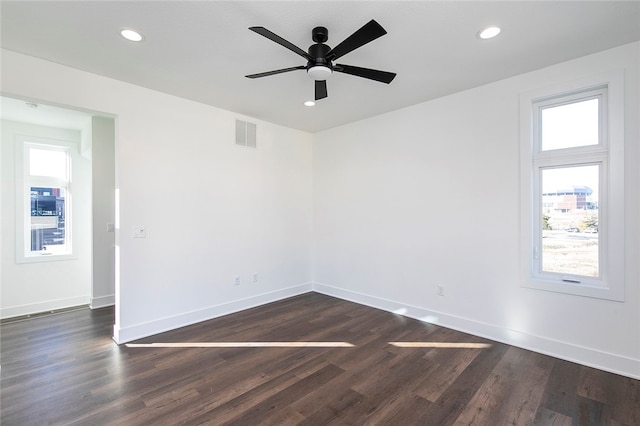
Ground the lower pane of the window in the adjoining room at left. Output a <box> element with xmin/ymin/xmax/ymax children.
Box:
<box><xmin>30</xmin><ymin>187</ymin><xmax>67</xmax><ymax>254</ymax></box>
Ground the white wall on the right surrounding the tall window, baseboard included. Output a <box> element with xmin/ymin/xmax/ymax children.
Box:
<box><xmin>313</xmin><ymin>43</ymin><xmax>640</xmax><ymax>377</ymax></box>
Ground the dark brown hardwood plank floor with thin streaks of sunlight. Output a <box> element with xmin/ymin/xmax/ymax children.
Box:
<box><xmin>0</xmin><ymin>293</ymin><xmax>640</xmax><ymax>426</ymax></box>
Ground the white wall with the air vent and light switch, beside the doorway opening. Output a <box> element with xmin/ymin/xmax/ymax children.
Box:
<box><xmin>2</xmin><ymin>50</ymin><xmax>312</xmax><ymax>342</ymax></box>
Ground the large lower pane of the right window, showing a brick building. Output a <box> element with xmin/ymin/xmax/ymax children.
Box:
<box><xmin>541</xmin><ymin>165</ymin><xmax>600</xmax><ymax>277</ymax></box>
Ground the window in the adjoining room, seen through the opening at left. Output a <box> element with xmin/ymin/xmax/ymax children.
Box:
<box><xmin>16</xmin><ymin>136</ymin><xmax>73</xmax><ymax>262</ymax></box>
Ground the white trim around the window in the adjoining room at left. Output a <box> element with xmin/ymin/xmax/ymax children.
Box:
<box><xmin>15</xmin><ymin>135</ymin><xmax>78</xmax><ymax>263</ymax></box>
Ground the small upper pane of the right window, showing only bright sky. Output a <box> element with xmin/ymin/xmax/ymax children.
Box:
<box><xmin>540</xmin><ymin>98</ymin><xmax>600</xmax><ymax>151</ymax></box>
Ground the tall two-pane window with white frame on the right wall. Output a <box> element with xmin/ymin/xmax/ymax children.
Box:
<box><xmin>521</xmin><ymin>75</ymin><xmax>624</xmax><ymax>300</ymax></box>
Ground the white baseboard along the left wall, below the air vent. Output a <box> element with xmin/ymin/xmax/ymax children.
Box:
<box><xmin>113</xmin><ymin>283</ymin><xmax>312</xmax><ymax>344</ymax></box>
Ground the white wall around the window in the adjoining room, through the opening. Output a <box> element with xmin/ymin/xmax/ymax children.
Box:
<box><xmin>0</xmin><ymin>120</ymin><xmax>91</xmax><ymax>318</ymax></box>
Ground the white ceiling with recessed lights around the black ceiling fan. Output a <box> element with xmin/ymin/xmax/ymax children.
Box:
<box><xmin>0</xmin><ymin>0</ymin><xmax>640</xmax><ymax>132</ymax></box>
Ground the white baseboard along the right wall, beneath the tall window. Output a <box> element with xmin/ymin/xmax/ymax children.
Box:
<box><xmin>313</xmin><ymin>282</ymin><xmax>640</xmax><ymax>379</ymax></box>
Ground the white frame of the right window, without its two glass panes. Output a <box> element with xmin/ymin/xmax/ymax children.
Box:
<box><xmin>520</xmin><ymin>72</ymin><xmax>625</xmax><ymax>301</ymax></box>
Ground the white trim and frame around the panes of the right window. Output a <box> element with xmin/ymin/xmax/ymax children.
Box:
<box><xmin>520</xmin><ymin>71</ymin><xmax>625</xmax><ymax>301</ymax></box>
